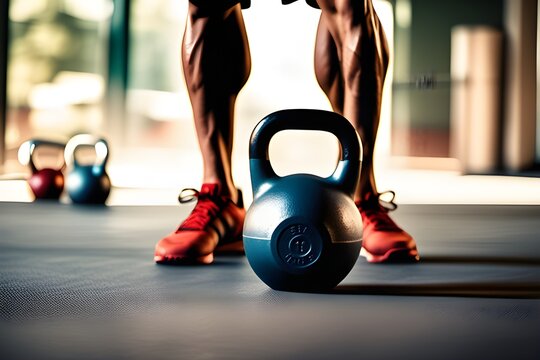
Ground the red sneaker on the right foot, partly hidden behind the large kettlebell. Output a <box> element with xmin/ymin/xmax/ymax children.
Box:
<box><xmin>356</xmin><ymin>191</ymin><xmax>420</xmax><ymax>263</ymax></box>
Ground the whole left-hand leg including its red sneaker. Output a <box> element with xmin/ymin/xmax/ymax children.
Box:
<box><xmin>154</xmin><ymin>0</ymin><xmax>251</xmax><ymax>264</ymax></box>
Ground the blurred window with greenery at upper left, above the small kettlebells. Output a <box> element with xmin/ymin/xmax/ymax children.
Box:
<box><xmin>6</xmin><ymin>0</ymin><xmax>113</xmax><ymax>171</ymax></box>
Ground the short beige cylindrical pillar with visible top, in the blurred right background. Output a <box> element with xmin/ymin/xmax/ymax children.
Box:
<box><xmin>450</xmin><ymin>26</ymin><xmax>503</xmax><ymax>174</ymax></box>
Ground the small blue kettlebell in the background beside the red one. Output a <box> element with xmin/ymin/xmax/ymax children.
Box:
<box><xmin>64</xmin><ymin>134</ymin><xmax>111</xmax><ymax>204</ymax></box>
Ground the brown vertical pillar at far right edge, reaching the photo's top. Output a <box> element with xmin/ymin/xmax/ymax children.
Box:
<box><xmin>503</xmin><ymin>0</ymin><xmax>538</xmax><ymax>171</ymax></box>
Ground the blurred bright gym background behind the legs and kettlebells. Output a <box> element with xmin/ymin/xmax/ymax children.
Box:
<box><xmin>0</xmin><ymin>0</ymin><xmax>540</xmax><ymax>205</ymax></box>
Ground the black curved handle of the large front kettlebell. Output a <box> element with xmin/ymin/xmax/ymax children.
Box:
<box><xmin>249</xmin><ymin>109</ymin><xmax>362</xmax><ymax>196</ymax></box>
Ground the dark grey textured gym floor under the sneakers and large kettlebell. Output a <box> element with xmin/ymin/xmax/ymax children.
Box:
<box><xmin>0</xmin><ymin>202</ymin><xmax>540</xmax><ymax>359</ymax></box>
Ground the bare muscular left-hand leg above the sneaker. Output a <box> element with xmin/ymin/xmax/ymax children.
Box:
<box><xmin>182</xmin><ymin>2</ymin><xmax>251</xmax><ymax>201</ymax></box>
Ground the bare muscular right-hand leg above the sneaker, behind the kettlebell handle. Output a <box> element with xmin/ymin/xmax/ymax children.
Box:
<box><xmin>315</xmin><ymin>0</ymin><xmax>389</xmax><ymax>200</ymax></box>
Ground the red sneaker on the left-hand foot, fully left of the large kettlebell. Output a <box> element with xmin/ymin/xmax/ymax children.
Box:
<box><xmin>154</xmin><ymin>184</ymin><xmax>246</xmax><ymax>264</ymax></box>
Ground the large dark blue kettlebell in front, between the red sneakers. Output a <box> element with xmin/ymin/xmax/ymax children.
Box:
<box><xmin>243</xmin><ymin>109</ymin><xmax>362</xmax><ymax>292</ymax></box>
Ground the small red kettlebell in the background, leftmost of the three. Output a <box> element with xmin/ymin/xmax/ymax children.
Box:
<box><xmin>18</xmin><ymin>139</ymin><xmax>65</xmax><ymax>200</ymax></box>
